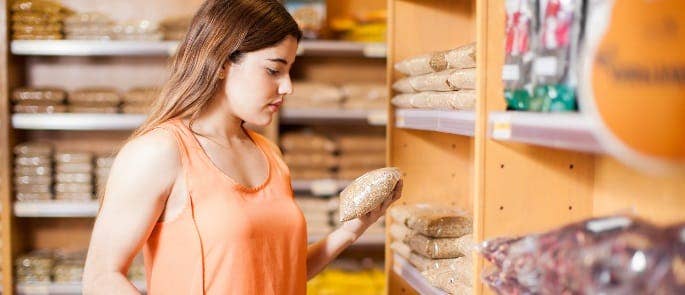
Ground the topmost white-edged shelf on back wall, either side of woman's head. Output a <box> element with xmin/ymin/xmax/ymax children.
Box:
<box><xmin>11</xmin><ymin>40</ymin><xmax>386</xmax><ymax>58</ymax></box>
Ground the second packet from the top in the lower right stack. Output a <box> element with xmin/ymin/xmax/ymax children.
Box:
<box><xmin>407</xmin><ymin>234</ymin><xmax>475</xmax><ymax>259</ymax></box>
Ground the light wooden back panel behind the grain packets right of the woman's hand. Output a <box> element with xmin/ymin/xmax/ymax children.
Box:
<box><xmin>386</xmin><ymin>0</ymin><xmax>476</xmax><ymax>294</ymax></box>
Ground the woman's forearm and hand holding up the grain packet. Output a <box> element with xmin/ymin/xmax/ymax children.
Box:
<box><xmin>307</xmin><ymin>180</ymin><xmax>402</xmax><ymax>280</ymax></box>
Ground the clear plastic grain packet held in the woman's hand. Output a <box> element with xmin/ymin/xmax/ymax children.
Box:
<box><xmin>340</xmin><ymin>167</ymin><xmax>402</xmax><ymax>221</ymax></box>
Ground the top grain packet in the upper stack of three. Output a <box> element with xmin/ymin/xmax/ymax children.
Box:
<box><xmin>395</xmin><ymin>43</ymin><xmax>476</xmax><ymax>76</ymax></box>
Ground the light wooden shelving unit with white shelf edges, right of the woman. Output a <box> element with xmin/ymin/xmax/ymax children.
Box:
<box><xmin>386</xmin><ymin>0</ymin><xmax>685</xmax><ymax>294</ymax></box>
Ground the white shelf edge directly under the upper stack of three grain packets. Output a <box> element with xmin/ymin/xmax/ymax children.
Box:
<box><xmin>395</xmin><ymin>109</ymin><xmax>476</xmax><ymax>136</ymax></box>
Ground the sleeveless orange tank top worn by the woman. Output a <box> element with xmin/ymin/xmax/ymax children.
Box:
<box><xmin>143</xmin><ymin>120</ymin><xmax>307</xmax><ymax>295</ymax></box>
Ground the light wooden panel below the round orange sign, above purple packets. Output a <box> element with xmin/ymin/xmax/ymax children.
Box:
<box><xmin>594</xmin><ymin>157</ymin><xmax>685</xmax><ymax>224</ymax></box>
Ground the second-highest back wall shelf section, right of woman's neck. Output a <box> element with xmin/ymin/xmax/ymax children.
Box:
<box><xmin>280</xmin><ymin>108</ymin><xmax>387</xmax><ymax>125</ymax></box>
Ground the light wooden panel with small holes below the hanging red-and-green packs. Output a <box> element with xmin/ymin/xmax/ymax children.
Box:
<box><xmin>481</xmin><ymin>1</ymin><xmax>594</xmax><ymax>238</ymax></box>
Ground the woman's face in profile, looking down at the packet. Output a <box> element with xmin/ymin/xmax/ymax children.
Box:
<box><xmin>223</xmin><ymin>36</ymin><xmax>297</xmax><ymax>126</ymax></box>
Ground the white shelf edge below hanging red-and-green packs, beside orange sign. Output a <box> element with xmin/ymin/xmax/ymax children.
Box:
<box><xmin>488</xmin><ymin>112</ymin><xmax>604</xmax><ymax>153</ymax></box>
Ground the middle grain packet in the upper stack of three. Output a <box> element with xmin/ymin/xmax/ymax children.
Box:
<box><xmin>392</xmin><ymin>69</ymin><xmax>476</xmax><ymax>93</ymax></box>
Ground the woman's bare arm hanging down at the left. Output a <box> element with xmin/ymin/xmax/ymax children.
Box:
<box><xmin>83</xmin><ymin>130</ymin><xmax>180</xmax><ymax>294</ymax></box>
